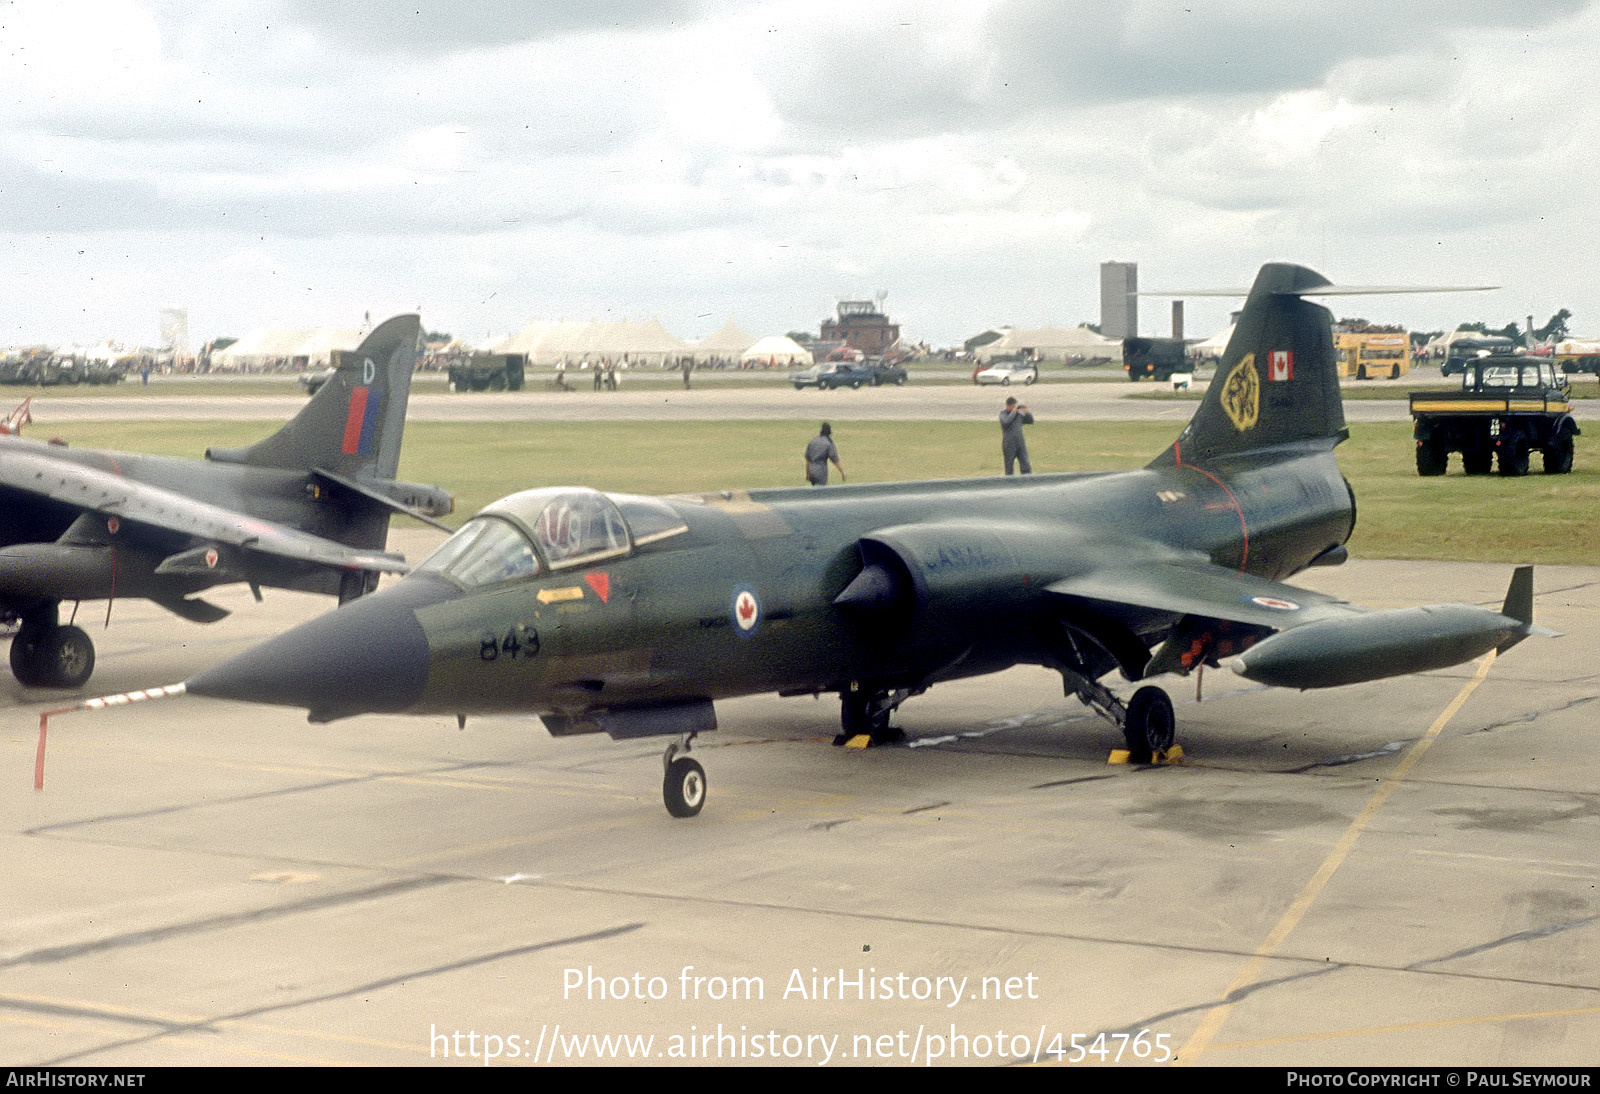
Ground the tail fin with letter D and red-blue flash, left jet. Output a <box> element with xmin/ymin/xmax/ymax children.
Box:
<box><xmin>206</xmin><ymin>315</ymin><xmax>422</xmax><ymax>478</ymax></box>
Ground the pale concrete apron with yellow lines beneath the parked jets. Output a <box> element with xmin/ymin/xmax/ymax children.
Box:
<box><xmin>0</xmin><ymin>531</ymin><xmax>1600</xmax><ymax>1067</ymax></box>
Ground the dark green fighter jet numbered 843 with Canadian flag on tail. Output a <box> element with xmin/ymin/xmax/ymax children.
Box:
<box><xmin>181</xmin><ymin>264</ymin><xmax>1549</xmax><ymax>816</ymax></box>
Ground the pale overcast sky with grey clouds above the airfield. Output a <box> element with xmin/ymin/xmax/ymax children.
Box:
<box><xmin>0</xmin><ymin>0</ymin><xmax>1600</xmax><ymax>345</ymax></box>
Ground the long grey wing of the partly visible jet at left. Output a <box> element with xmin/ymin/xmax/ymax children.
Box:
<box><xmin>0</xmin><ymin>451</ymin><xmax>408</xmax><ymax>574</ymax></box>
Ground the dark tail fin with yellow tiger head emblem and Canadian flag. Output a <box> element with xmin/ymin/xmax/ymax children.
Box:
<box><xmin>1150</xmin><ymin>262</ymin><xmax>1347</xmax><ymax>467</ymax></box>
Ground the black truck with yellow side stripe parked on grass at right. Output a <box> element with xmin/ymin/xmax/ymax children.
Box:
<box><xmin>1411</xmin><ymin>357</ymin><xmax>1581</xmax><ymax>475</ymax></box>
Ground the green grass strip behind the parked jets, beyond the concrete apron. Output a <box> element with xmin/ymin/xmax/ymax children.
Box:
<box><xmin>50</xmin><ymin>421</ymin><xmax>1600</xmax><ymax>566</ymax></box>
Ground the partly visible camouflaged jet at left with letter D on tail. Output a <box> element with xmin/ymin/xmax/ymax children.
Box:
<box><xmin>0</xmin><ymin>315</ymin><xmax>453</xmax><ymax>688</ymax></box>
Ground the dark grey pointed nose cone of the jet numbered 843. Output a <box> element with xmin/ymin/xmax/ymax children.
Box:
<box><xmin>186</xmin><ymin>579</ymin><xmax>456</xmax><ymax>721</ymax></box>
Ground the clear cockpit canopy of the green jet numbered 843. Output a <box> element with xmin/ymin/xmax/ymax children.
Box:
<box><xmin>418</xmin><ymin>486</ymin><xmax>688</xmax><ymax>587</ymax></box>
